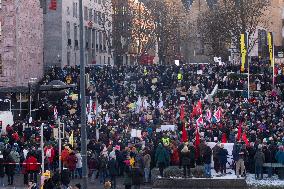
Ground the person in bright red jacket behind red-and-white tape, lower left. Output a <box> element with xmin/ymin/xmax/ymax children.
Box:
<box><xmin>25</xmin><ymin>153</ymin><xmax>39</xmax><ymax>183</ymax></box>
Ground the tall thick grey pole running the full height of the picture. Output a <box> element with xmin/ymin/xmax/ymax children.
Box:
<box><xmin>79</xmin><ymin>0</ymin><xmax>88</xmax><ymax>189</ymax></box>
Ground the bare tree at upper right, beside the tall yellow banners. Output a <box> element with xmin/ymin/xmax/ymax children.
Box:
<box><xmin>196</xmin><ymin>0</ymin><xmax>270</xmax><ymax>56</ymax></box>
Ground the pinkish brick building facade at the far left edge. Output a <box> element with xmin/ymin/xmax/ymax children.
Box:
<box><xmin>0</xmin><ymin>0</ymin><xmax>43</xmax><ymax>87</ymax></box>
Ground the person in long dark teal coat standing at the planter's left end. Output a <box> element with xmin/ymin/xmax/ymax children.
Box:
<box><xmin>155</xmin><ymin>143</ymin><xmax>170</xmax><ymax>177</ymax></box>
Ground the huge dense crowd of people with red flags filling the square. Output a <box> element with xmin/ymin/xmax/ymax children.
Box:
<box><xmin>0</xmin><ymin>64</ymin><xmax>284</xmax><ymax>188</ymax></box>
